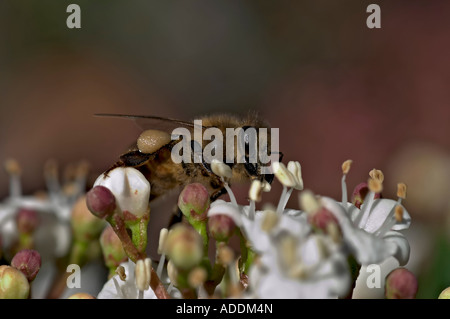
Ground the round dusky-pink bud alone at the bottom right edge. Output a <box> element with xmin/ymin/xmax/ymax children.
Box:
<box><xmin>385</xmin><ymin>268</ymin><xmax>417</xmax><ymax>299</ymax></box>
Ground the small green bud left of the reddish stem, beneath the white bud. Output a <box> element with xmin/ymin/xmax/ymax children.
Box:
<box><xmin>100</xmin><ymin>225</ymin><xmax>128</xmax><ymax>269</ymax></box>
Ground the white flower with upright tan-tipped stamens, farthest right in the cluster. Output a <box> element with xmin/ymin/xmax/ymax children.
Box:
<box><xmin>321</xmin><ymin>161</ymin><xmax>411</xmax><ymax>266</ymax></box>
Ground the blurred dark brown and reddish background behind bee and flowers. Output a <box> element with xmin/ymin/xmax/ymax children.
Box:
<box><xmin>0</xmin><ymin>0</ymin><xmax>450</xmax><ymax>298</ymax></box>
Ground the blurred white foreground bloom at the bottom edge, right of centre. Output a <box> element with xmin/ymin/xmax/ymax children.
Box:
<box><xmin>249</xmin><ymin>235</ymin><xmax>351</xmax><ymax>299</ymax></box>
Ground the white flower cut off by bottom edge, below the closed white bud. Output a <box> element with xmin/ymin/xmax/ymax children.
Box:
<box><xmin>97</xmin><ymin>260</ymin><xmax>156</xmax><ymax>299</ymax></box>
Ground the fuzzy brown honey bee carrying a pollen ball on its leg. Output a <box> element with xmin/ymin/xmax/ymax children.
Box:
<box><xmin>97</xmin><ymin>114</ymin><xmax>283</xmax><ymax>201</ymax></box>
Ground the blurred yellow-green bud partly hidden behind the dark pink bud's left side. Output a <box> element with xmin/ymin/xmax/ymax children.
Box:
<box><xmin>71</xmin><ymin>196</ymin><xmax>105</xmax><ymax>241</ymax></box>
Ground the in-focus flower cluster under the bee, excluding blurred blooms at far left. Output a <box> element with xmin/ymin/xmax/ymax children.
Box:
<box><xmin>83</xmin><ymin>161</ymin><xmax>417</xmax><ymax>298</ymax></box>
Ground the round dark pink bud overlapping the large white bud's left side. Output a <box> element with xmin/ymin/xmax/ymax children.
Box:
<box><xmin>86</xmin><ymin>186</ymin><xmax>116</xmax><ymax>218</ymax></box>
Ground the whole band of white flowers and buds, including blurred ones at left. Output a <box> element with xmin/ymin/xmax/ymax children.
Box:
<box><xmin>0</xmin><ymin>156</ymin><xmax>448</xmax><ymax>299</ymax></box>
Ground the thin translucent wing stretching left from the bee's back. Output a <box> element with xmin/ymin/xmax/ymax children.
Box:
<box><xmin>95</xmin><ymin>114</ymin><xmax>205</xmax><ymax>134</ymax></box>
